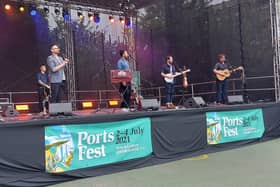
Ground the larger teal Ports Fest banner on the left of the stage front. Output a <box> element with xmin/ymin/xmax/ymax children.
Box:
<box><xmin>45</xmin><ymin>118</ymin><xmax>152</xmax><ymax>173</ymax></box>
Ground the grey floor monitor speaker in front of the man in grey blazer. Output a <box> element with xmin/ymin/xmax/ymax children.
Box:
<box><xmin>49</xmin><ymin>103</ymin><xmax>72</xmax><ymax>116</ymax></box>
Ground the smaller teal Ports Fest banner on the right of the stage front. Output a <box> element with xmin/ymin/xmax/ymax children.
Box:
<box><xmin>206</xmin><ymin>109</ymin><xmax>264</xmax><ymax>144</ymax></box>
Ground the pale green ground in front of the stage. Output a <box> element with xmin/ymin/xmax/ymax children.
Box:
<box><xmin>49</xmin><ymin>139</ymin><xmax>280</xmax><ymax>187</ymax></box>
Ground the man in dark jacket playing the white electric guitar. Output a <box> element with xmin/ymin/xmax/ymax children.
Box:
<box><xmin>161</xmin><ymin>56</ymin><xmax>176</xmax><ymax>109</ymax></box>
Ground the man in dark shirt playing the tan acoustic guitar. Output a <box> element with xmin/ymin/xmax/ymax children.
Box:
<box><xmin>213</xmin><ymin>54</ymin><xmax>229</xmax><ymax>105</ymax></box>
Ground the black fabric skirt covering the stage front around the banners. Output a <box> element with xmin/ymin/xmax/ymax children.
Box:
<box><xmin>0</xmin><ymin>104</ymin><xmax>280</xmax><ymax>187</ymax></box>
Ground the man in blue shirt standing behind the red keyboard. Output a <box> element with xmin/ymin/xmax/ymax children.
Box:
<box><xmin>117</xmin><ymin>50</ymin><xmax>131</xmax><ymax>111</ymax></box>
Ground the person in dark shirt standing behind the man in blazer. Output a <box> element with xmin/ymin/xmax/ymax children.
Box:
<box><xmin>37</xmin><ymin>64</ymin><xmax>50</xmax><ymax>115</ymax></box>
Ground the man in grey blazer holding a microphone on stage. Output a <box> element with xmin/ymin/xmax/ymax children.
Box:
<box><xmin>47</xmin><ymin>45</ymin><xmax>69</xmax><ymax>103</ymax></box>
